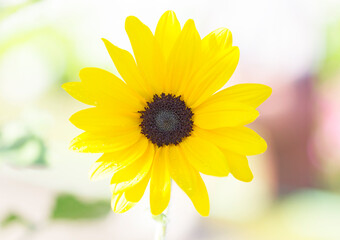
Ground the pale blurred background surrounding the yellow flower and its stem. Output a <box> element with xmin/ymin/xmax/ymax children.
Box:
<box><xmin>0</xmin><ymin>0</ymin><xmax>340</xmax><ymax>240</ymax></box>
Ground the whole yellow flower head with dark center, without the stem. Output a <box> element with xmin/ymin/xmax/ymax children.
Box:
<box><xmin>63</xmin><ymin>11</ymin><xmax>271</xmax><ymax>216</ymax></box>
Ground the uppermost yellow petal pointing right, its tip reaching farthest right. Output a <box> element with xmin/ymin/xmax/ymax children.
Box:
<box><xmin>203</xmin><ymin>83</ymin><xmax>272</xmax><ymax>108</ymax></box>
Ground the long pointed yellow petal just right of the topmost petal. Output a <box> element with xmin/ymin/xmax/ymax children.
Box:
<box><xmin>165</xmin><ymin>19</ymin><xmax>201</xmax><ymax>95</ymax></box>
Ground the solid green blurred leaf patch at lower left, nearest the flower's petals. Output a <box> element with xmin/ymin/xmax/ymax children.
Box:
<box><xmin>51</xmin><ymin>194</ymin><xmax>111</xmax><ymax>220</ymax></box>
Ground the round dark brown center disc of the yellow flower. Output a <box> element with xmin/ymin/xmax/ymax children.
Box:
<box><xmin>139</xmin><ymin>93</ymin><xmax>193</xmax><ymax>147</ymax></box>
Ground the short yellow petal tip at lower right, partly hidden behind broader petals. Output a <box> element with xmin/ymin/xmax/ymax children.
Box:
<box><xmin>222</xmin><ymin>149</ymin><xmax>253</xmax><ymax>182</ymax></box>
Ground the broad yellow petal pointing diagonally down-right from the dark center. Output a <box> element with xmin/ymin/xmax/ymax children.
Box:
<box><xmin>180</xmin><ymin>136</ymin><xmax>229</xmax><ymax>177</ymax></box>
